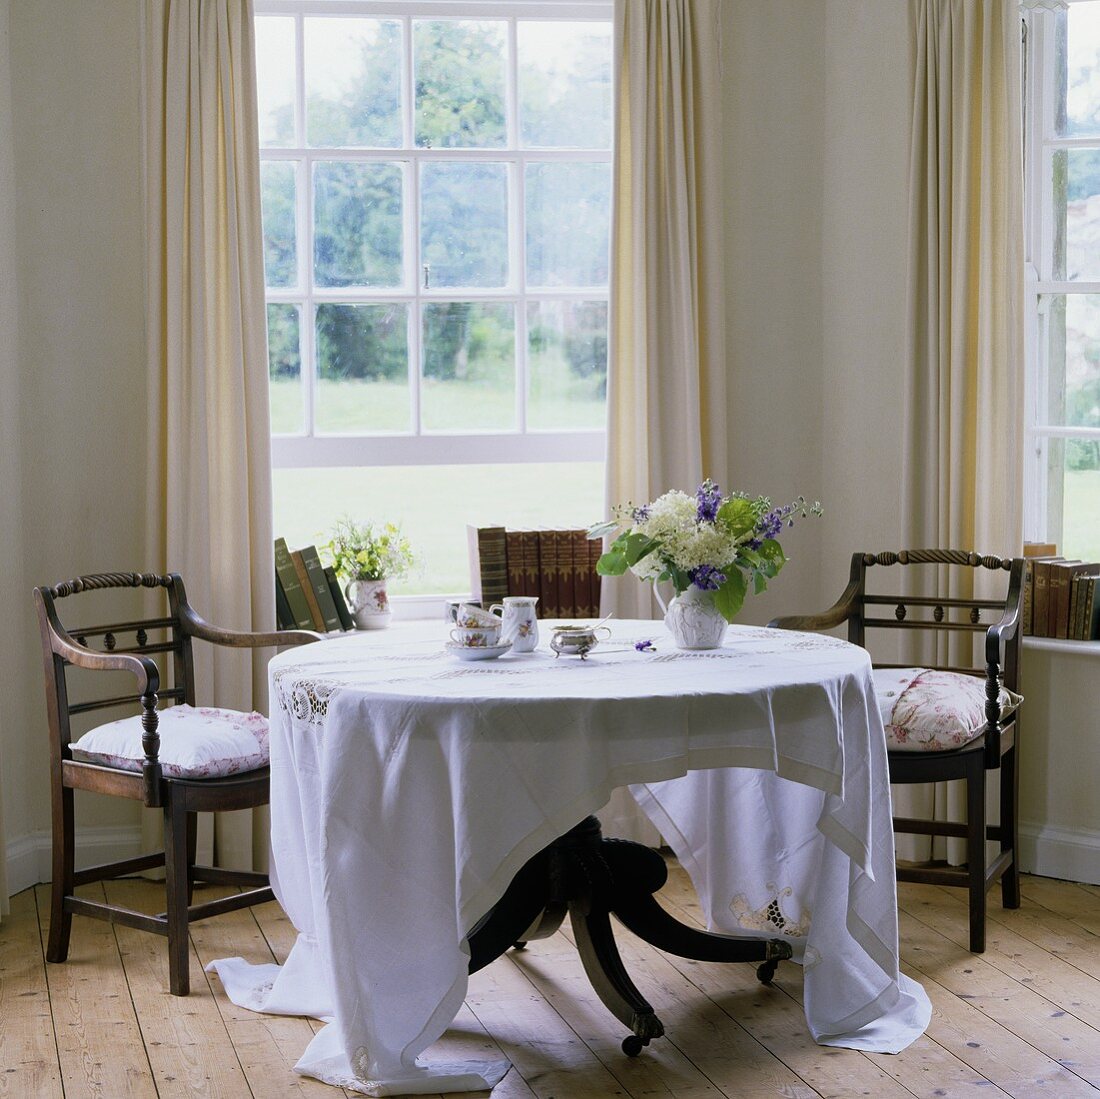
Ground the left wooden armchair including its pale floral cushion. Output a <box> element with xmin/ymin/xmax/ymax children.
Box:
<box><xmin>34</xmin><ymin>572</ymin><xmax>319</xmax><ymax>996</ymax></box>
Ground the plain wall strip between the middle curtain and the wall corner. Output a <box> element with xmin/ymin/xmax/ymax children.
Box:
<box><xmin>715</xmin><ymin>0</ymin><xmax>836</xmax><ymax>623</ymax></box>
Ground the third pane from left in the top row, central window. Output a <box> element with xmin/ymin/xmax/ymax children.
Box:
<box><xmin>413</xmin><ymin>19</ymin><xmax>507</xmax><ymax>149</ymax></box>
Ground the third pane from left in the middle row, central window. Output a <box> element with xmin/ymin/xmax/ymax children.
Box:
<box><xmin>420</xmin><ymin>162</ymin><xmax>508</xmax><ymax>287</ymax></box>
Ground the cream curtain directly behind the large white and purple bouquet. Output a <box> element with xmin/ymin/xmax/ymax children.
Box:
<box><xmin>603</xmin><ymin>0</ymin><xmax>727</xmax><ymax>618</ymax></box>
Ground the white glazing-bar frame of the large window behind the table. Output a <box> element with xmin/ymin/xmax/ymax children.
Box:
<box><xmin>255</xmin><ymin>0</ymin><xmax>612</xmax><ymax>469</ymax></box>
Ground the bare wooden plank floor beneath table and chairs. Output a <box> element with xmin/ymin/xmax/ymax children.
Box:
<box><xmin>0</xmin><ymin>866</ymin><xmax>1100</xmax><ymax>1099</ymax></box>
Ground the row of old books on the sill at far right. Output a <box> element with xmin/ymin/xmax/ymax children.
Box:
<box><xmin>1023</xmin><ymin>546</ymin><xmax>1100</xmax><ymax>641</ymax></box>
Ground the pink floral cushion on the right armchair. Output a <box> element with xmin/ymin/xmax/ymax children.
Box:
<box><xmin>875</xmin><ymin>668</ymin><xmax>1023</xmax><ymax>751</ymax></box>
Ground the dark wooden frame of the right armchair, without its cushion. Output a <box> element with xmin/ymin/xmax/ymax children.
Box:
<box><xmin>768</xmin><ymin>550</ymin><xmax>1024</xmax><ymax>954</ymax></box>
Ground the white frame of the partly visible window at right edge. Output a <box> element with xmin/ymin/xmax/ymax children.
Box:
<box><xmin>1023</xmin><ymin>0</ymin><xmax>1100</xmax><ymax>547</ymax></box>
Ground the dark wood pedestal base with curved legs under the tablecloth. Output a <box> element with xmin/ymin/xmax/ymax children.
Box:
<box><xmin>470</xmin><ymin>816</ymin><xmax>791</xmax><ymax>1057</ymax></box>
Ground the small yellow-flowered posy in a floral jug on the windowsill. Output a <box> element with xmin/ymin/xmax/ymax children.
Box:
<box><xmin>322</xmin><ymin>516</ymin><xmax>416</xmax><ymax>629</ymax></box>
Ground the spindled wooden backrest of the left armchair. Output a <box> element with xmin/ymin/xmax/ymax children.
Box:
<box><xmin>34</xmin><ymin>572</ymin><xmax>195</xmax><ymax>796</ymax></box>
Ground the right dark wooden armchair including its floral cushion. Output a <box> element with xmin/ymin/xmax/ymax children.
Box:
<box><xmin>769</xmin><ymin>550</ymin><xmax>1024</xmax><ymax>953</ymax></box>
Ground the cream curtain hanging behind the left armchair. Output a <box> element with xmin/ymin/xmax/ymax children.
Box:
<box><xmin>145</xmin><ymin>0</ymin><xmax>275</xmax><ymax>868</ymax></box>
